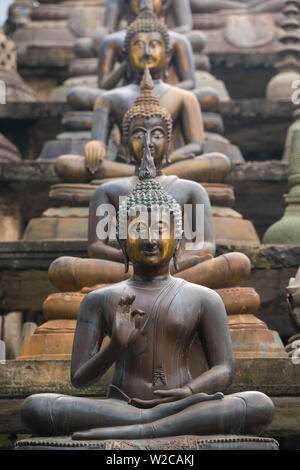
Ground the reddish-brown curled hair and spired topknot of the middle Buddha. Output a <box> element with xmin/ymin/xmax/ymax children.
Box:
<box><xmin>122</xmin><ymin>67</ymin><xmax>173</xmax><ymax>144</ymax></box>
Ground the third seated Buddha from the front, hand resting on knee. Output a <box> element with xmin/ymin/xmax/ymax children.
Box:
<box><xmin>56</xmin><ymin>10</ymin><xmax>241</xmax><ymax>182</ymax></box>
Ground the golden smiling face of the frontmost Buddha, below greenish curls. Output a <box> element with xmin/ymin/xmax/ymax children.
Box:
<box><xmin>125</xmin><ymin>210</ymin><xmax>176</xmax><ymax>267</ymax></box>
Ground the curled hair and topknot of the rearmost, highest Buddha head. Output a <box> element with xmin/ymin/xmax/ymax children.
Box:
<box><xmin>124</xmin><ymin>2</ymin><xmax>171</xmax><ymax>56</ymax></box>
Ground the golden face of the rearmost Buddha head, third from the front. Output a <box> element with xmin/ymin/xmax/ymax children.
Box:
<box><xmin>129</xmin><ymin>32</ymin><xmax>167</xmax><ymax>75</ymax></box>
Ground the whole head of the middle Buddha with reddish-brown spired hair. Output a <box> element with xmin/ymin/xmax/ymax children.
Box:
<box><xmin>123</xmin><ymin>68</ymin><xmax>173</xmax><ymax>169</ymax></box>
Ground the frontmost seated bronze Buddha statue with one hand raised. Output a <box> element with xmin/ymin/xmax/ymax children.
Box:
<box><xmin>21</xmin><ymin>159</ymin><xmax>274</xmax><ymax>440</ymax></box>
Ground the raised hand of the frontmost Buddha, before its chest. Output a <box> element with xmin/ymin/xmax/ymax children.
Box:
<box><xmin>111</xmin><ymin>295</ymin><xmax>145</xmax><ymax>351</ymax></box>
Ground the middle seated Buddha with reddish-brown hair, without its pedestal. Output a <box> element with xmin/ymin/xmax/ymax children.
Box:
<box><xmin>49</xmin><ymin>68</ymin><xmax>250</xmax><ymax>290</ymax></box>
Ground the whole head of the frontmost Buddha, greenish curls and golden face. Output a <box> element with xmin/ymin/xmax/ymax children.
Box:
<box><xmin>117</xmin><ymin>146</ymin><xmax>182</xmax><ymax>272</ymax></box>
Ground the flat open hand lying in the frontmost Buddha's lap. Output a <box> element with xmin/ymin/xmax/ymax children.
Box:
<box><xmin>130</xmin><ymin>387</ymin><xmax>224</xmax><ymax>408</ymax></box>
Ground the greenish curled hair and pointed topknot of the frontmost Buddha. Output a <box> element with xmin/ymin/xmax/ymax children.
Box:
<box><xmin>117</xmin><ymin>142</ymin><xmax>182</xmax><ymax>240</ymax></box>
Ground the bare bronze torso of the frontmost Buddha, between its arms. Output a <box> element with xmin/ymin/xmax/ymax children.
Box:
<box><xmin>98</xmin><ymin>278</ymin><xmax>207</xmax><ymax>400</ymax></box>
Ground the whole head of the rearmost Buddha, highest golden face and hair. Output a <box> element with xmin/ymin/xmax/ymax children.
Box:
<box><xmin>124</xmin><ymin>9</ymin><xmax>170</xmax><ymax>78</ymax></box>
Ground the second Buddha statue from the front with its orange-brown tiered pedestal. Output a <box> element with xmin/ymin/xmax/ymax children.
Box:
<box><xmin>18</xmin><ymin>70</ymin><xmax>286</xmax><ymax>360</ymax></box>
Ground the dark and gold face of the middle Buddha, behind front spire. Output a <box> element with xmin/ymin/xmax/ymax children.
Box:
<box><xmin>129</xmin><ymin>116</ymin><xmax>168</xmax><ymax>167</ymax></box>
